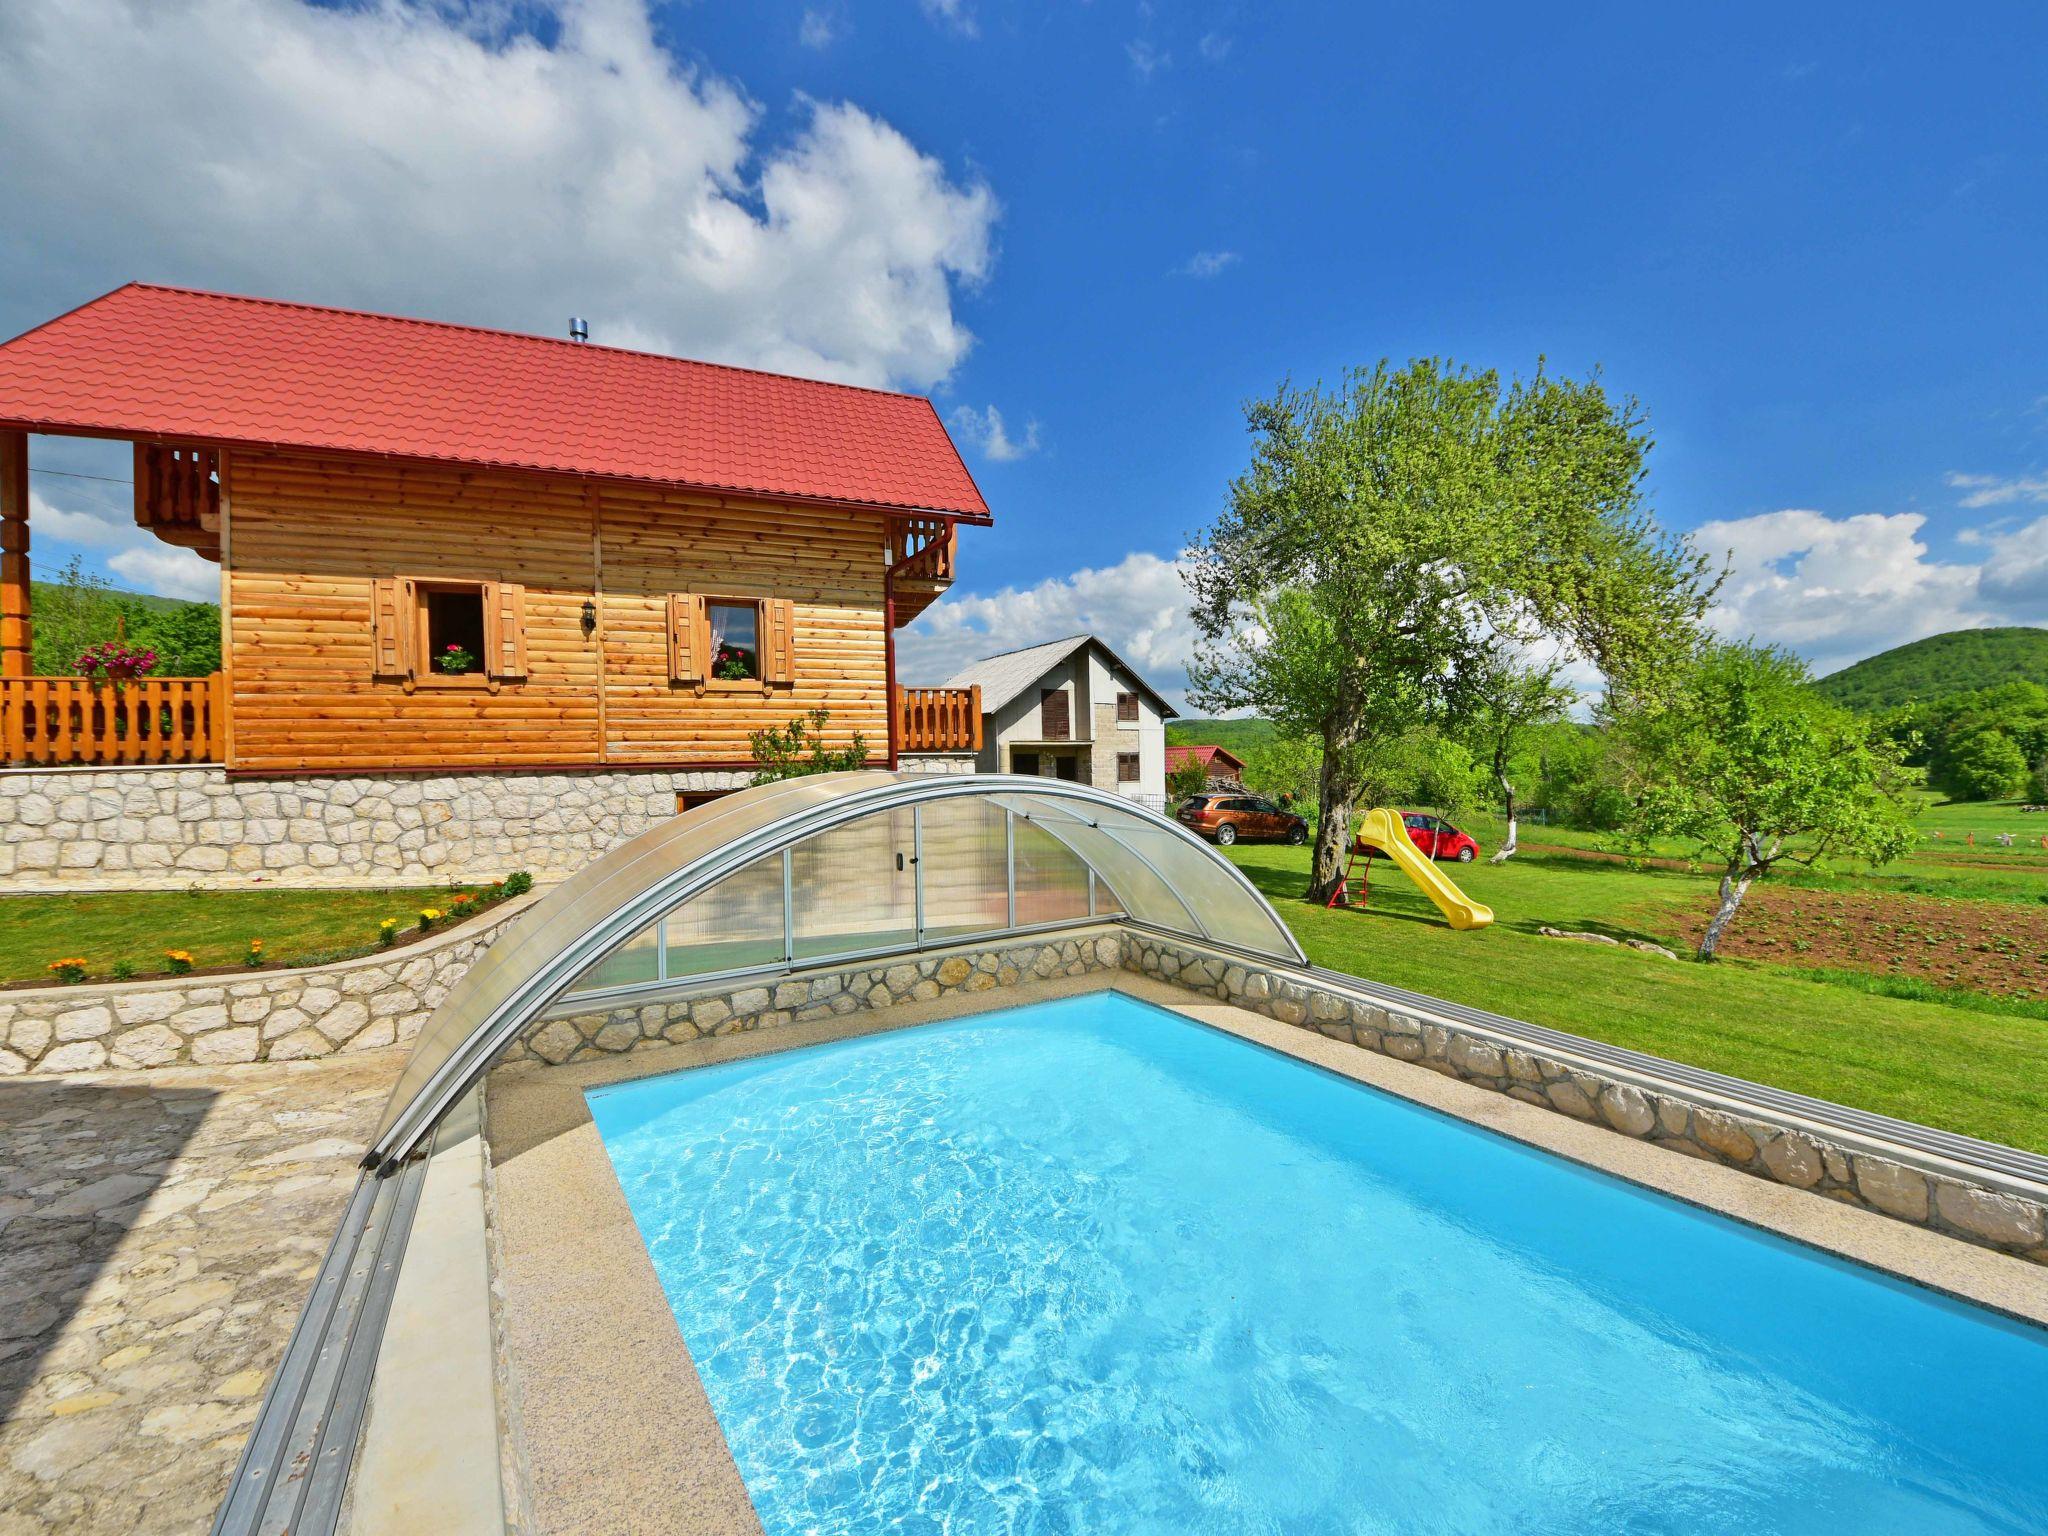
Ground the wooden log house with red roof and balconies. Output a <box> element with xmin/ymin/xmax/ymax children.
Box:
<box><xmin>0</xmin><ymin>285</ymin><xmax>989</xmax><ymax>776</ymax></box>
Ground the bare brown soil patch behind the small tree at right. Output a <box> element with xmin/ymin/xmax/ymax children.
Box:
<box><xmin>1686</xmin><ymin>889</ymin><xmax>2048</xmax><ymax>997</ymax></box>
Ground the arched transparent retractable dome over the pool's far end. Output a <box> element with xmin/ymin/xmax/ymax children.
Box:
<box><xmin>371</xmin><ymin>772</ymin><xmax>1307</xmax><ymax>1167</ymax></box>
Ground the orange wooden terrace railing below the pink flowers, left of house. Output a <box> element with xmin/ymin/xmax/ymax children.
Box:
<box><xmin>0</xmin><ymin>672</ymin><xmax>227</xmax><ymax>766</ymax></box>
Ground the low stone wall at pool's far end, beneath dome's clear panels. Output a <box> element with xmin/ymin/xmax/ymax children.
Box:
<box><xmin>504</xmin><ymin>930</ymin><xmax>1124</xmax><ymax>1067</ymax></box>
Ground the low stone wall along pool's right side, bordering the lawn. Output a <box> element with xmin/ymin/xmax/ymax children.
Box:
<box><xmin>1124</xmin><ymin>934</ymin><xmax>2048</xmax><ymax>1264</ymax></box>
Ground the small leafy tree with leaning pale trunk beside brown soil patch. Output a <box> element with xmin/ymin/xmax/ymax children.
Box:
<box><xmin>1616</xmin><ymin>643</ymin><xmax>1913</xmax><ymax>961</ymax></box>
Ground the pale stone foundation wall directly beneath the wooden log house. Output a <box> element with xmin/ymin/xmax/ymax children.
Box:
<box><xmin>0</xmin><ymin>768</ymin><xmax>745</xmax><ymax>893</ymax></box>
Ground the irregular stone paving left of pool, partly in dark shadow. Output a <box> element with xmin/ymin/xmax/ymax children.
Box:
<box><xmin>0</xmin><ymin>1051</ymin><xmax>403</xmax><ymax>1536</ymax></box>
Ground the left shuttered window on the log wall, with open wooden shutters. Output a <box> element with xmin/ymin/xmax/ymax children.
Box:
<box><xmin>371</xmin><ymin>575</ymin><xmax>526</xmax><ymax>688</ymax></box>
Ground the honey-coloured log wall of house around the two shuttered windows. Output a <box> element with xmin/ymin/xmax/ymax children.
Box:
<box><xmin>227</xmin><ymin>451</ymin><xmax>889</xmax><ymax>772</ymax></box>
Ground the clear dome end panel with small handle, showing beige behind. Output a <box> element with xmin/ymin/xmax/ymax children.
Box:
<box><xmin>788</xmin><ymin>805</ymin><xmax>918</xmax><ymax>961</ymax></box>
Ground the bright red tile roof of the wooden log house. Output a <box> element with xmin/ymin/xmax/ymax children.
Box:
<box><xmin>0</xmin><ymin>283</ymin><xmax>989</xmax><ymax>522</ymax></box>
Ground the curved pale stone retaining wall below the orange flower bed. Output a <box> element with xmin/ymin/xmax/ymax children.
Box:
<box><xmin>0</xmin><ymin>897</ymin><xmax>532</xmax><ymax>1075</ymax></box>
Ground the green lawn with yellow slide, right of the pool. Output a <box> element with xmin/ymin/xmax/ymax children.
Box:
<box><xmin>1231</xmin><ymin>844</ymin><xmax>2048</xmax><ymax>1151</ymax></box>
